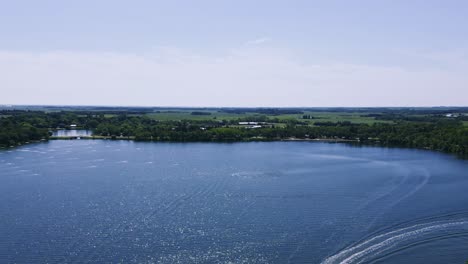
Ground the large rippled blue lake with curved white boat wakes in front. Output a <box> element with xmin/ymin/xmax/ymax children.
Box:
<box><xmin>0</xmin><ymin>140</ymin><xmax>468</xmax><ymax>264</ymax></box>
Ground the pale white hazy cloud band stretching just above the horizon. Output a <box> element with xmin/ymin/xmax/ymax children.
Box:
<box><xmin>0</xmin><ymin>47</ymin><xmax>468</xmax><ymax>106</ymax></box>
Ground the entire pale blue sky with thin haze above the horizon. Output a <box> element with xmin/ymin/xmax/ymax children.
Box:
<box><xmin>0</xmin><ymin>0</ymin><xmax>468</xmax><ymax>107</ymax></box>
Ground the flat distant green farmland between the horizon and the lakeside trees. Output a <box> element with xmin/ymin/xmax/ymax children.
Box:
<box><xmin>0</xmin><ymin>106</ymin><xmax>460</xmax><ymax>127</ymax></box>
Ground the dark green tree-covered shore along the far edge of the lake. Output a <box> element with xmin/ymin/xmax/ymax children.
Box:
<box><xmin>0</xmin><ymin>111</ymin><xmax>468</xmax><ymax>157</ymax></box>
